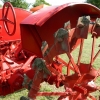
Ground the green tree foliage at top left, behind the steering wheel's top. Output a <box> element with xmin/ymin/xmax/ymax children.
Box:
<box><xmin>2</xmin><ymin>0</ymin><xmax>30</xmax><ymax>9</ymax></box>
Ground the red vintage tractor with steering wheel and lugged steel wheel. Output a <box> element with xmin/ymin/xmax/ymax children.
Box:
<box><xmin>0</xmin><ymin>2</ymin><xmax>100</xmax><ymax>100</ymax></box>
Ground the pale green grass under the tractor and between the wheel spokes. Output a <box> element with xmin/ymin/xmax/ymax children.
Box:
<box><xmin>0</xmin><ymin>35</ymin><xmax>100</xmax><ymax>100</ymax></box>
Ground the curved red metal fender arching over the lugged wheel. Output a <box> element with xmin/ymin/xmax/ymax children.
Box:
<box><xmin>20</xmin><ymin>3</ymin><xmax>100</xmax><ymax>57</ymax></box>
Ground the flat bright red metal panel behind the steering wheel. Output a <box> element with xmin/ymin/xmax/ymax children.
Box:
<box><xmin>0</xmin><ymin>8</ymin><xmax>31</xmax><ymax>41</ymax></box>
